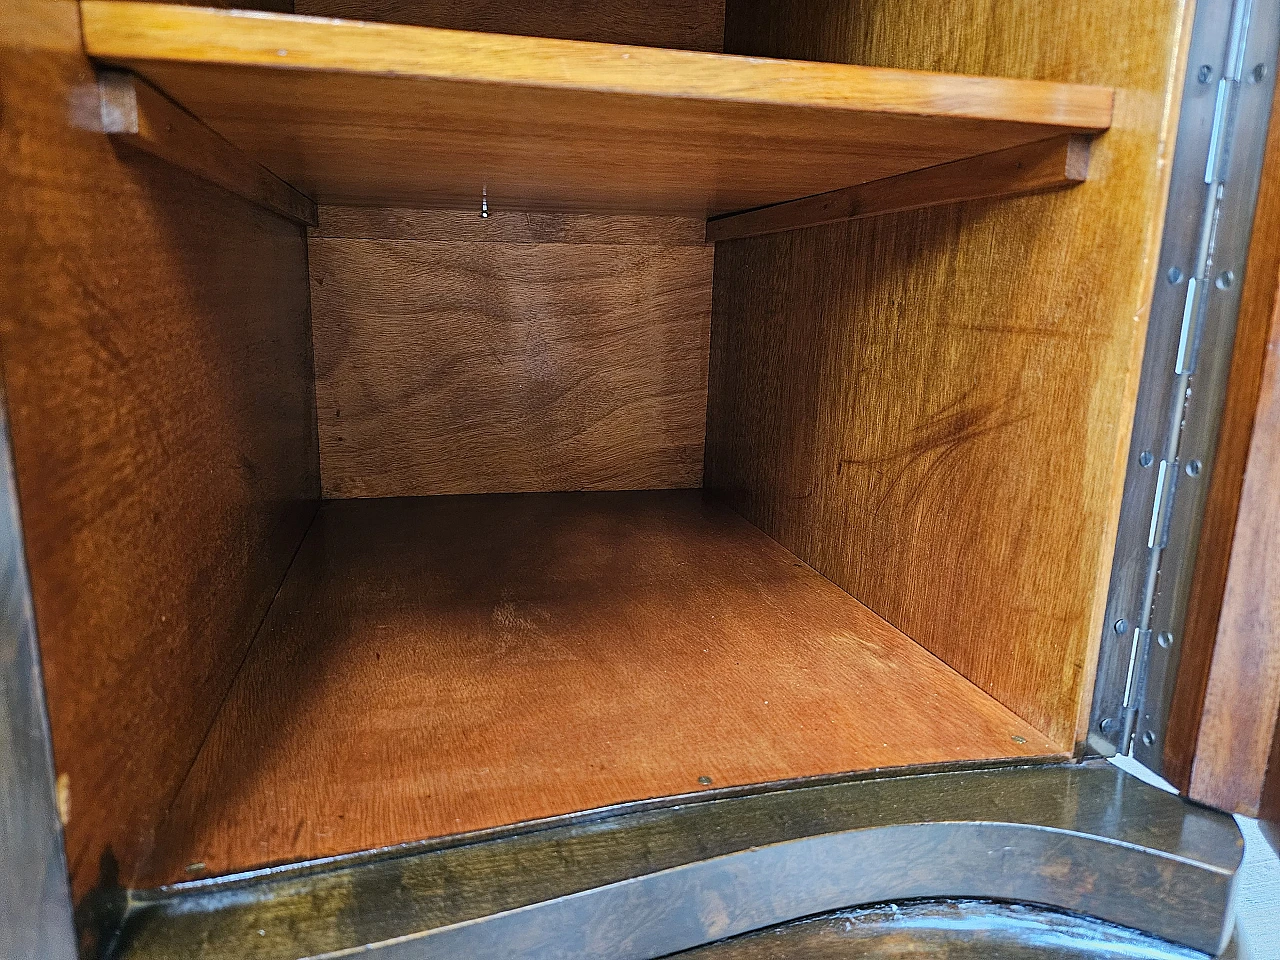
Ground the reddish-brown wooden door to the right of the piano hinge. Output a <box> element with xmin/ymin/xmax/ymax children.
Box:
<box><xmin>1164</xmin><ymin>80</ymin><xmax>1280</xmax><ymax>815</ymax></box>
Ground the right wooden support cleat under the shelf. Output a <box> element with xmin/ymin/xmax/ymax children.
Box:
<box><xmin>707</xmin><ymin>136</ymin><xmax>1089</xmax><ymax>241</ymax></box>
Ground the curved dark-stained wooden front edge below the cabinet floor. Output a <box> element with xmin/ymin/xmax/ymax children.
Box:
<box><xmin>116</xmin><ymin>763</ymin><xmax>1243</xmax><ymax>960</ymax></box>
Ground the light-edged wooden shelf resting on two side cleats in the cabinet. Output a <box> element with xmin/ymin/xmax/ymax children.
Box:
<box><xmin>81</xmin><ymin>0</ymin><xmax>1112</xmax><ymax>216</ymax></box>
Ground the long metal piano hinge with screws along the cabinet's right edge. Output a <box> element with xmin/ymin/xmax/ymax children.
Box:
<box><xmin>1089</xmin><ymin>0</ymin><xmax>1280</xmax><ymax>771</ymax></box>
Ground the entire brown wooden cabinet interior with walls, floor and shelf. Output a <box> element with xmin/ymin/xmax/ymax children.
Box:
<box><xmin>3</xmin><ymin>0</ymin><xmax>1185</xmax><ymax>916</ymax></box>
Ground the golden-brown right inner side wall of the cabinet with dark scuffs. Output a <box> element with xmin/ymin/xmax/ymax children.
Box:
<box><xmin>707</xmin><ymin>0</ymin><xmax>1187</xmax><ymax>748</ymax></box>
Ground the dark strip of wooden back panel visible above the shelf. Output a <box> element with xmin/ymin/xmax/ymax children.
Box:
<box><xmin>294</xmin><ymin>0</ymin><xmax>724</xmax><ymax>52</ymax></box>
